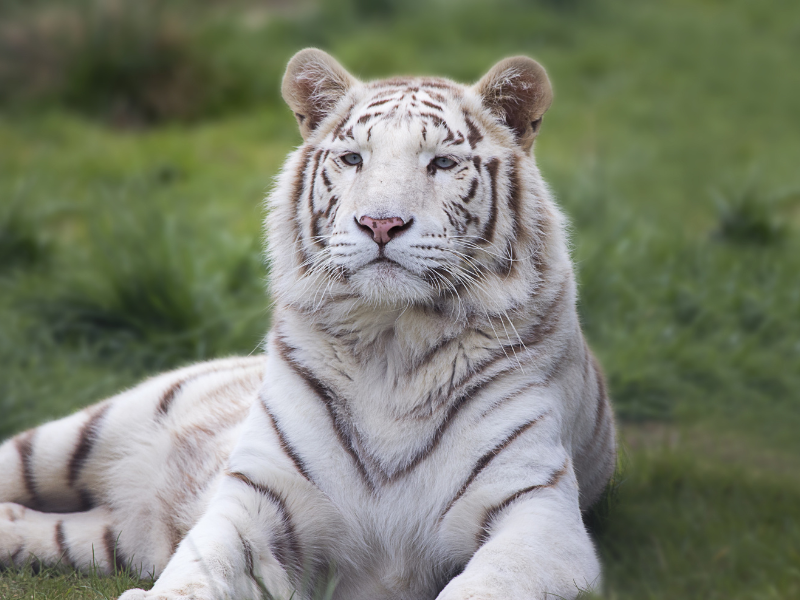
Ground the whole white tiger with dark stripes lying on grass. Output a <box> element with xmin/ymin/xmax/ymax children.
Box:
<box><xmin>0</xmin><ymin>49</ymin><xmax>615</xmax><ymax>600</ymax></box>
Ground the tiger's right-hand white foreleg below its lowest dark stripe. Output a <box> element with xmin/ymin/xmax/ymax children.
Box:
<box><xmin>437</xmin><ymin>466</ymin><xmax>600</xmax><ymax>600</ymax></box>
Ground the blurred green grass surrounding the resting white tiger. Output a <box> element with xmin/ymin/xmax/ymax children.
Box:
<box><xmin>0</xmin><ymin>0</ymin><xmax>800</xmax><ymax>600</ymax></box>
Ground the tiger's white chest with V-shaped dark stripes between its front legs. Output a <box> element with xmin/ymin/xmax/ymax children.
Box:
<box><xmin>253</xmin><ymin>356</ymin><xmax>544</xmax><ymax>584</ymax></box>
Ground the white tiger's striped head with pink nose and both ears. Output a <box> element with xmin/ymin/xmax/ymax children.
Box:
<box><xmin>268</xmin><ymin>49</ymin><xmax>565</xmax><ymax>312</ymax></box>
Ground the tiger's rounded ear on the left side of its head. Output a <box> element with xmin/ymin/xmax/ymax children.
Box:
<box><xmin>281</xmin><ymin>48</ymin><xmax>357</xmax><ymax>139</ymax></box>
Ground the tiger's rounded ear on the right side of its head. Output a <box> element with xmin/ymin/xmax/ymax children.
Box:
<box><xmin>473</xmin><ymin>56</ymin><xmax>553</xmax><ymax>151</ymax></box>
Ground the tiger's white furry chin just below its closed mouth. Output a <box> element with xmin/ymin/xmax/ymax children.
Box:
<box><xmin>349</xmin><ymin>260</ymin><xmax>434</xmax><ymax>307</ymax></box>
